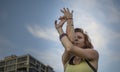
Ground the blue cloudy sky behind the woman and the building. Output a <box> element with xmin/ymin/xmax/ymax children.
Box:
<box><xmin>0</xmin><ymin>0</ymin><xmax>120</xmax><ymax>72</ymax></box>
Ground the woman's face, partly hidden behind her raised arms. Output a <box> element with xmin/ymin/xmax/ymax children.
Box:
<box><xmin>74</xmin><ymin>32</ymin><xmax>85</xmax><ymax>48</ymax></box>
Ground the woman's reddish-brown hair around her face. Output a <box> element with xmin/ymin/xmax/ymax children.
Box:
<box><xmin>75</xmin><ymin>28</ymin><xmax>93</xmax><ymax>48</ymax></box>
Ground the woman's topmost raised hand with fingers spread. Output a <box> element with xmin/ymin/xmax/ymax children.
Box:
<box><xmin>59</xmin><ymin>8</ymin><xmax>73</xmax><ymax>20</ymax></box>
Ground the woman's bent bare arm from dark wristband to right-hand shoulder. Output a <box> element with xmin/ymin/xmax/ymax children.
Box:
<box><xmin>61</xmin><ymin>36</ymin><xmax>99</xmax><ymax>60</ymax></box>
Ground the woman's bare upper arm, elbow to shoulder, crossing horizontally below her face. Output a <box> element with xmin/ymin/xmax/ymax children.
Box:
<box><xmin>69</xmin><ymin>46</ymin><xmax>99</xmax><ymax>60</ymax></box>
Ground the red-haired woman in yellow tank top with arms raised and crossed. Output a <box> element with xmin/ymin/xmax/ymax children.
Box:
<box><xmin>55</xmin><ymin>8</ymin><xmax>99</xmax><ymax>72</ymax></box>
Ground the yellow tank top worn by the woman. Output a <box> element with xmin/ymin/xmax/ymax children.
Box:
<box><xmin>65</xmin><ymin>60</ymin><xmax>93</xmax><ymax>72</ymax></box>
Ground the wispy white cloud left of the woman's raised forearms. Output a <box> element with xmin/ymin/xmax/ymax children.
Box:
<box><xmin>27</xmin><ymin>25</ymin><xmax>58</xmax><ymax>41</ymax></box>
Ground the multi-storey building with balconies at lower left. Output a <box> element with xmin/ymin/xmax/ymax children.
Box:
<box><xmin>0</xmin><ymin>54</ymin><xmax>54</xmax><ymax>72</ymax></box>
